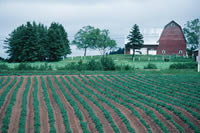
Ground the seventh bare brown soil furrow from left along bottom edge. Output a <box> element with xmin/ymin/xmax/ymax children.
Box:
<box><xmin>69</xmin><ymin>76</ymin><xmax>114</xmax><ymax>133</ymax></box>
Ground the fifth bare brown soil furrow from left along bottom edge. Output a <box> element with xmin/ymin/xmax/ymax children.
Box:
<box><xmin>51</xmin><ymin>76</ymin><xmax>82</xmax><ymax>133</ymax></box>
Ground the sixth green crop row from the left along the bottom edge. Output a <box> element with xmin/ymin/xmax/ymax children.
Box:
<box><xmin>54</xmin><ymin>76</ymin><xmax>90</xmax><ymax>133</ymax></box>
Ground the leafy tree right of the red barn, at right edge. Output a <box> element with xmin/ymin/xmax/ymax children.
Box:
<box><xmin>183</xmin><ymin>19</ymin><xmax>200</xmax><ymax>56</ymax></box>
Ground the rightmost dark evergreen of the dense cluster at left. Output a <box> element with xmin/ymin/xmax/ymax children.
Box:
<box><xmin>47</xmin><ymin>23</ymin><xmax>71</xmax><ymax>61</ymax></box>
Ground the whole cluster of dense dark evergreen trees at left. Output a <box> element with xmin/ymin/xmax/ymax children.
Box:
<box><xmin>5</xmin><ymin>22</ymin><xmax>71</xmax><ymax>62</ymax></box>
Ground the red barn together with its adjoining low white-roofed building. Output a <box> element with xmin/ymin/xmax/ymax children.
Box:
<box><xmin>124</xmin><ymin>21</ymin><xmax>186</xmax><ymax>56</ymax></box>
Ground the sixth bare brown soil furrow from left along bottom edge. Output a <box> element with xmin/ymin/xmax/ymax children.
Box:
<box><xmin>58</xmin><ymin>78</ymin><xmax>97</xmax><ymax>133</ymax></box>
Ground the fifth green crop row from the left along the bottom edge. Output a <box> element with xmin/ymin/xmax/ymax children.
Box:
<box><xmin>47</xmin><ymin>76</ymin><xmax>72</xmax><ymax>133</ymax></box>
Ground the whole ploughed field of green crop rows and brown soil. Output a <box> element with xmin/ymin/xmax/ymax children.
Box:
<box><xmin>0</xmin><ymin>73</ymin><xmax>200</xmax><ymax>133</ymax></box>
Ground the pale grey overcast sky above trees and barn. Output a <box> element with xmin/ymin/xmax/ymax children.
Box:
<box><xmin>0</xmin><ymin>0</ymin><xmax>200</xmax><ymax>57</ymax></box>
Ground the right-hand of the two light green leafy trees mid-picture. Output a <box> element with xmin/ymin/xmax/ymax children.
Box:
<box><xmin>95</xmin><ymin>30</ymin><xmax>117</xmax><ymax>57</ymax></box>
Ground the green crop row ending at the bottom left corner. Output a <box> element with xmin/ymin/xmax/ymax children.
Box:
<box><xmin>1</xmin><ymin>77</ymin><xmax>24</xmax><ymax>133</ymax></box>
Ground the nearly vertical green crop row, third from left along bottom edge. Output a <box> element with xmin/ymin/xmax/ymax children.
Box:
<box><xmin>33</xmin><ymin>77</ymin><xmax>40</xmax><ymax>133</ymax></box>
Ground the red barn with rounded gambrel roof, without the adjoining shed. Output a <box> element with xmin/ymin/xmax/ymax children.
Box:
<box><xmin>157</xmin><ymin>21</ymin><xmax>186</xmax><ymax>56</ymax></box>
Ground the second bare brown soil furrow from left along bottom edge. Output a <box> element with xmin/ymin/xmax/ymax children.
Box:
<box><xmin>26</xmin><ymin>76</ymin><xmax>34</xmax><ymax>133</ymax></box>
